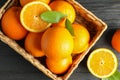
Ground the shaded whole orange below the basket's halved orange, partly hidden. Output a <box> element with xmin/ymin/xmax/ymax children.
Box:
<box><xmin>24</xmin><ymin>32</ymin><xmax>44</xmax><ymax>57</ymax></box>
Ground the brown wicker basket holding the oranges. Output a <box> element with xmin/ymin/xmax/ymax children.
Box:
<box><xmin>0</xmin><ymin>0</ymin><xmax>107</xmax><ymax>80</ymax></box>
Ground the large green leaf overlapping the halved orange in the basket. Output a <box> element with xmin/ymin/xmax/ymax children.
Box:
<box><xmin>40</xmin><ymin>11</ymin><xmax>66</xmax><ymax>23</ymax></box>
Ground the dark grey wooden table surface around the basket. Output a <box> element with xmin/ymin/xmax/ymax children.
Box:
<box><xmin>0</xmin><ymin>0</ymin><xmax>120</xmax><ymax>80</ymax></box>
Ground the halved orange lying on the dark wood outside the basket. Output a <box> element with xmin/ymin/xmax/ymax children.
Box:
<box><xmin>87</xmin><ymin>48</ymin><xmax>118</xmax><ymax>78</ymax></box>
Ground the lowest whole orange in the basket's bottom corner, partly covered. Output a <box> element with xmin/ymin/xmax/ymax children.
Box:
<box><xmin>46</xmin><ymin>56</ymin><xmax>72</xmax><ymax>74</ymax></box>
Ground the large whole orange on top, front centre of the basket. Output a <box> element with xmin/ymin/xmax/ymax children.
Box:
<box><xmin>41</xmin><ymin>27</ymin><xmax>74</xmax><ymax>59</ymax></box>
